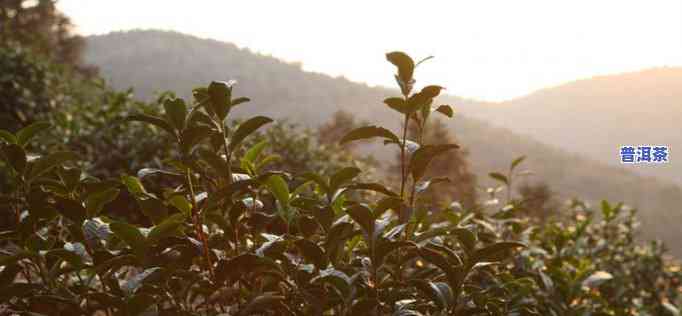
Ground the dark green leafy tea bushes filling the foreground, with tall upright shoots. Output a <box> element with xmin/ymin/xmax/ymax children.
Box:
<box><xmin>0</xmin><ymin>52</ymin><xmax>679</xmax><ymax>316</ymax></box>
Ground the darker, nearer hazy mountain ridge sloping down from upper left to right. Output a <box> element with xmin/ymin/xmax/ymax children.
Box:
<box><xmin>85</xmin><ymin>31</ymin><xmax>682</xmax><ymax>255</ymax></box>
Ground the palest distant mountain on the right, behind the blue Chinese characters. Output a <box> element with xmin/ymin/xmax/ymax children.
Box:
<box><xmin>462</xmin><ymin>67</ymin><xmax>682</xmax><ymax>184</ymax></box>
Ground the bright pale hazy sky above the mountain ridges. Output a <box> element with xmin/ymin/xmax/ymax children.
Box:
<box><xmin>59</xmin><ymin>0</ymin><xmax>682</xmax><ymax>100</ymax></box>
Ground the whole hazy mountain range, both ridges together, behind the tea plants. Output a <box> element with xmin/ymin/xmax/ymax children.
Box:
<box><xmin>85</xmin><ymin>31</ymin><xmax>682</xmax><ymax>255</ymax></box>
